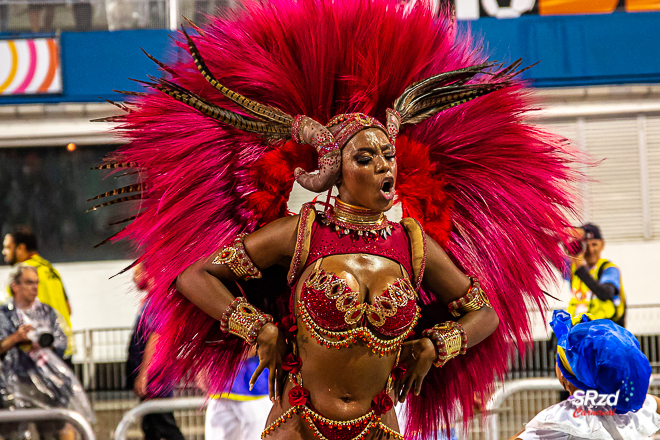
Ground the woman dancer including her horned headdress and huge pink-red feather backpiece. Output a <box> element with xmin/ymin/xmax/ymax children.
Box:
<box><xmin>90</xmin><ymin>0</ymin><xmax>575</xmax><ymax>439</ymax></box>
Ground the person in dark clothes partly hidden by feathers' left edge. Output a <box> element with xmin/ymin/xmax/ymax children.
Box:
<box><xmin>126</xmin><ymin>264</ymin><xmax>184</xmax><ymax>440</ymax></box>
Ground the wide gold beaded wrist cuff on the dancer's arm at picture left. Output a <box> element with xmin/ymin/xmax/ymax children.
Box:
<box><xmin>220</xmin><ymin>296</ymin><xmax>273</xmax><ymax>345</ymax></box>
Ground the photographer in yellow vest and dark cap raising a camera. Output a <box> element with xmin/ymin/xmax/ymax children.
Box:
<box><xmin>567</xmin><ymin>223</ymin><xmax>626</xmax><ymax>327</ymax></box>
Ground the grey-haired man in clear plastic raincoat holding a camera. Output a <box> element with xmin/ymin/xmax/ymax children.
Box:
<box><xmin>0</xmin><ymin>263</ymin><xmax>71</xmax><ymax>440</ymax></box>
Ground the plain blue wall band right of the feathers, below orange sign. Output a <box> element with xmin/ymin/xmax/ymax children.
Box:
<box><xmin>460</xmin><ymin>13</ymin><xmax>660</xmax><ymax>87</ymax></box>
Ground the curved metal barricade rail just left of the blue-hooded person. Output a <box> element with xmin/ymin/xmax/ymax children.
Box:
<box><xmin>485</xmin><ymin>374</ymin><xmax>660</xmax><ymax>440</ymax></box>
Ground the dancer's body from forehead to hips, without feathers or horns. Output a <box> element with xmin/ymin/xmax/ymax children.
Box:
<box><xmin>176</xmin><ymin>124</ymin><xmax>498</xmax><ymax>438</ymax></box>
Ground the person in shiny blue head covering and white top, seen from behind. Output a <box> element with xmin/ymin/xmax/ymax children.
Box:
<box><xmin>511</xmin><ymin>310</ymin><xmax>660</xmax><ymax>440</ymax></box>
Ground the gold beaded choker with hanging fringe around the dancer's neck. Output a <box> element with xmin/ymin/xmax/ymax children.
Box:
<box><xmin>321</xmin><ymin>199</ymin><xmax>392</xmax><ymax>242</ymax></box>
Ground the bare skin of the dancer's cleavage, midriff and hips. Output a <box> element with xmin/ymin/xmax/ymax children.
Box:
<box><xmin>267</xmin><ymin>254</ymin><xmax>402</xmax><ymax>439</ymax></box>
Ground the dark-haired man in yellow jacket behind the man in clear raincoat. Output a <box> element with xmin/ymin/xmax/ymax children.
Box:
<box><xmin>2</xmin><ymin>226</ymin><xmax>74</xmax><ymax>369</ymax></box>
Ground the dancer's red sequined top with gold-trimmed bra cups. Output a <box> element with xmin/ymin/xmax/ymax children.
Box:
<box><xmin>296</xmin><ymin>205</ymin><xmax>428</xmax><ymax>356</ymax></box>
